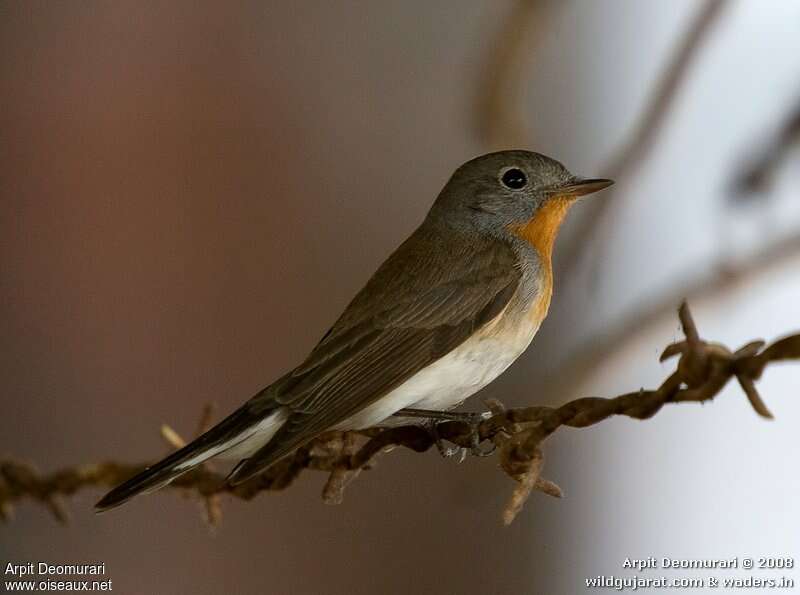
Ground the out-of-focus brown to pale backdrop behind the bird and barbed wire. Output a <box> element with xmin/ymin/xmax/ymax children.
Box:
<box><xmin>0</xmin><ymin>0</ymin><xmax>800</xmax><ymax>594</ymax></box>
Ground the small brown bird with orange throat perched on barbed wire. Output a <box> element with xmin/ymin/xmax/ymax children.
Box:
<box><xmin>96</xmin><ymin>150</ymin><xmax>613</xmax><ymax>511</ymax></box>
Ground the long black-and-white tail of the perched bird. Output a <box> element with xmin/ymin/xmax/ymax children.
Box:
<box><xmin>95</xmin><ymin>406</ymin><xmax>285</xmax><ymax>512</ymax></box>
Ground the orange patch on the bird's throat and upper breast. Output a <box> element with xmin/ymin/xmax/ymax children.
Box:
<box><xmin>511</xmin><ymin>196</ymin><xmax>574</xmax><ymax>324</ymax></box>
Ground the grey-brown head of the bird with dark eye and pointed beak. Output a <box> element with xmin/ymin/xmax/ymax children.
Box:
<box><xmin>428</xmin><ymin>150</ymin><xmax>613</xmax><ymax>233</ymax></box>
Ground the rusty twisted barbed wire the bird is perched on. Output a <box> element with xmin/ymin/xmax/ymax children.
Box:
<box><xmin>0</xmin><ymin>302</ymin><xmax>800</xmax><ymax>524</ymax></box>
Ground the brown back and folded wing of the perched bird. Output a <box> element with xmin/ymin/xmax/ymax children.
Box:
<box><xmin>230</xmin><ymin>226</ymin><xmax>521</xmax><ymax>483</ymax></box>
